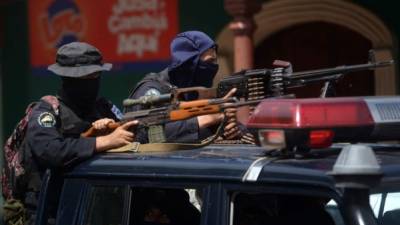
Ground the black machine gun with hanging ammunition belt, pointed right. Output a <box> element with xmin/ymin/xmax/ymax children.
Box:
<box><xmin>158</xmin><ymin>56</ymin><xmax>393</xmax><ymax>101</ymax></box>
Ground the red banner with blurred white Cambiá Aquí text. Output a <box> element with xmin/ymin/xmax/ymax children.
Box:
<box><xmin>29</xmin><ymin>0</ymin><xmax>178</xmax><ymax>73</ymax></box>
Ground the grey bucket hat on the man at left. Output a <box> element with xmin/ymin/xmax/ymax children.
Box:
<box><xmin>48</xmin><ymin>42</ymin><xmax>112</xmax><ymax>78</ymax></box>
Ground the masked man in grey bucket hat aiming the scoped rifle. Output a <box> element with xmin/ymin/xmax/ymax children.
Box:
<box><xmin>25</xmin><ymin>42</ymin><xmax>136</xmax><ymax>222</ymax></box>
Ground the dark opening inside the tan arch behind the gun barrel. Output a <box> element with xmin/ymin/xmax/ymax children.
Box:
<box><xmin>254</xmin><ymin>22</ymin><xmax>375</xmax><ymax>97</ymax></box>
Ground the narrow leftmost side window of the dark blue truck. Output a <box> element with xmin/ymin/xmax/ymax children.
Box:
<box><xmin>84</xmin><ymin>186</ymin><xmax>124</xmax><ymax>225</ymax></box>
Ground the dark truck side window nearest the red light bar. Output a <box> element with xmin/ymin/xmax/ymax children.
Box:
<box><xmin>230</xmin><ymin>193</ymin><xmax>335</xmax><ymax>225</ymax></box>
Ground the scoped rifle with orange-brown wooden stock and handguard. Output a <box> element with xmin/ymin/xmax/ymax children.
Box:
<box><xmin>81</xmin><ymin>94</ymin><xmax>262</xmax><ymax>138</ymax></box>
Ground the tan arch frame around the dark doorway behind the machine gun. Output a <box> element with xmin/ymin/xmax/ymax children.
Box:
<box><xmin>215</xmin><ymin>0</ymin><xmax>397</xmax><ymax>95</ymax></box>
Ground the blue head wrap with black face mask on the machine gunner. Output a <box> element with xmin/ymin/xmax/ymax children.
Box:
<box><xmin>168</xmin><ymin>31</ymin><xmax>218</xmax><ymax>88</ymax></box>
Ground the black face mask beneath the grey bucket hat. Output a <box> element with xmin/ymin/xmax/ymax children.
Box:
<box><xmin>59</xmin><ymin>77</ymin><xmax>100</xmax><ymax>117</ymax></box>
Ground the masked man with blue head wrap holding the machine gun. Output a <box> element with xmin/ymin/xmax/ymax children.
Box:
<box><xmin>127</xmin><ymin>31</ymin><xmax>239</xmax><ymax>143</ymax></box>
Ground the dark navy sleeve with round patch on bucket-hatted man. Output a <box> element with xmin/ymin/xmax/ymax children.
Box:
<box><xmin>26</xmin><ymin>102</ymin><xmax>96</xmax><ymax>168</ymax></box>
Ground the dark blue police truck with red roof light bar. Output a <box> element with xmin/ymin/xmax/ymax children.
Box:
<box><xmin>36</xmin><ymin>98</ymin><xmax>400</xmax><ymax>225</ymax></box>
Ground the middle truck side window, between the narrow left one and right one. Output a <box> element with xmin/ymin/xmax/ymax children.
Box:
<box><xmin>130</xmin><ymin>187</ymin><xmax>200</xmax><ymax>225</ymax></box>
